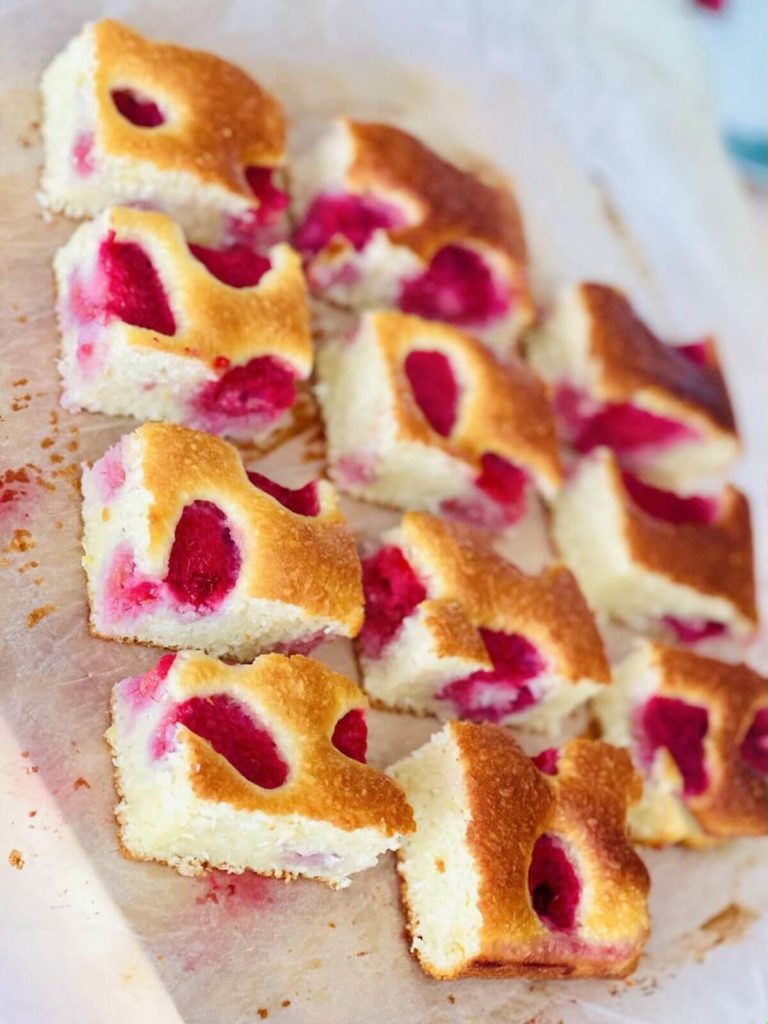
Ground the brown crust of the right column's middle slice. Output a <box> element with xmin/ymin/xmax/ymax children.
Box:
<box><xmin>601</xmin><ymin>452</ymin><xmax>758</xmax><ymax>624</ymax></box>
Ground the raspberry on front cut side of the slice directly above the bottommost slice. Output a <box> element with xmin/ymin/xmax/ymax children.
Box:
<box><xmin>435</xmin><ymin>629</ymin><xmax>547</xmax><ymax>722</ymax></box>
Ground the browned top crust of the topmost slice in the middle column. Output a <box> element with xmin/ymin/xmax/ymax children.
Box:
<box><xmin>342</xmin><ymin>119</ymin><xmax>532</xmax><ymax>276</ymax></box>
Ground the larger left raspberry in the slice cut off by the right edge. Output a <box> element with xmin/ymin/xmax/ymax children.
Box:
<box><xmin>637</xmin><ymin>697</ymin><xmax>710</xmax><ymax>797</ymax></box>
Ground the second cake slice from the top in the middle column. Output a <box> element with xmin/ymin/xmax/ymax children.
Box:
<box><xmin>316</xmin><ymin>311</ymin><xmax>561</xmax><ymax>529</ymax></box>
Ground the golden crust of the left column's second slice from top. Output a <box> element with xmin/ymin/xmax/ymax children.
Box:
<box><xmin>82</xmin><ymin>207</ymin><xmax>312</xmax><ymax>377</ymax></box>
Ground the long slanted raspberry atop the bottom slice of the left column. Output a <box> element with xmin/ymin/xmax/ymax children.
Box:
<box><xmin>155</xmin><ymin>693</ymin><xmax>288</xmax><ymax>790</ymax></box>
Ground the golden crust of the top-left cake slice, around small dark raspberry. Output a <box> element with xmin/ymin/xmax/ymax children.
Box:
<box><xmin>91</xmin><ymin>18</ymin><xmax>286</xmax><ymax>193</ymax></box>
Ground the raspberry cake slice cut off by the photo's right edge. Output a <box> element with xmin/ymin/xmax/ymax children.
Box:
<box><xmin>593</xmin><ymin>641</ymin><xmax>768</xmax><ymax>847</ymax></box>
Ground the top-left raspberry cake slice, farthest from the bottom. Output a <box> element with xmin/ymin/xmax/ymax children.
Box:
<box><xmin>41</xmin><ymin>19</ymin><xmax>288</xmax><ymax>246</ymax></box>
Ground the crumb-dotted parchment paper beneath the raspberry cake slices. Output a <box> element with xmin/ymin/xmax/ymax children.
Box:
<box><xmin>0</xmin><ymin>0</ymin><xmax>768</xmax><ymax>1024</ymax></box>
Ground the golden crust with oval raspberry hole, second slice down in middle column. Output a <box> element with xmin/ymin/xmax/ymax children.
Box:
<box><xmin>364</xmin><ymin>311</ymin><xmax>562</xmax><ymax>492</ymax></box>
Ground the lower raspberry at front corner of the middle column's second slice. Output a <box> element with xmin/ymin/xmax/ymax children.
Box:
<box><xmin>441</xmin><ymin>452</ymin><xmax>528</xmax><ymax>530</ymax></box>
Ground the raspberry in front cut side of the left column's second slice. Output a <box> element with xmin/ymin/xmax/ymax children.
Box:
<box><xmin>197</xmin><ymin>355</ymin><xmax>296</xmax><ymax>421</ymax></box>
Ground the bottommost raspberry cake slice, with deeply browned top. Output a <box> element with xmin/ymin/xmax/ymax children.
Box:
<box><xmin>389</xmin><ymin>722</ymin><xmax>649</xmax><ymax>978</ymax></box>
